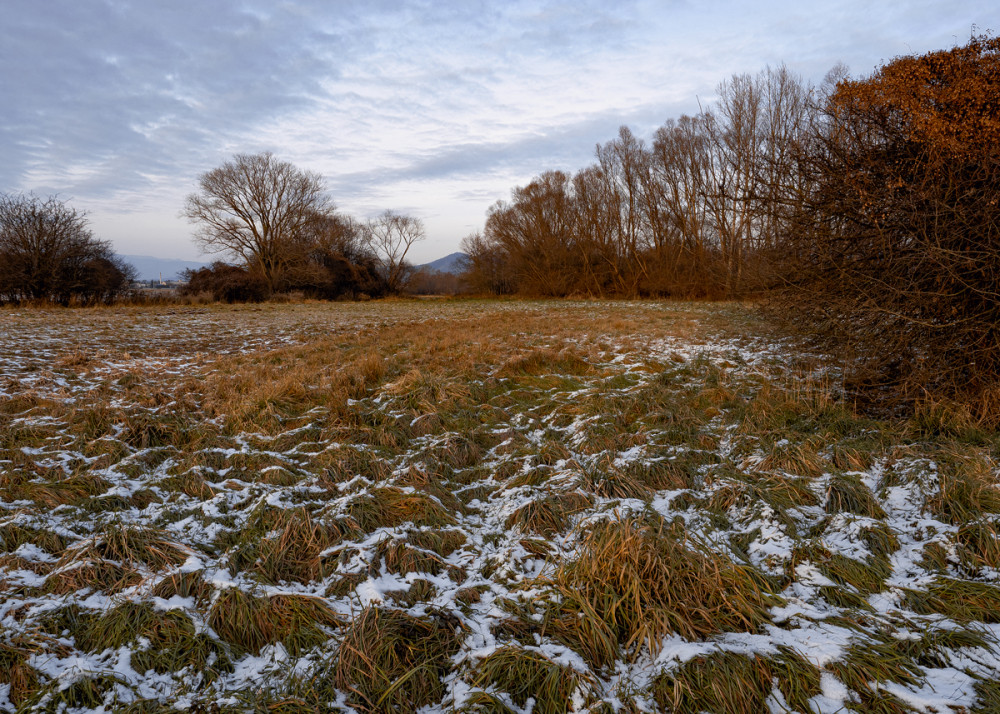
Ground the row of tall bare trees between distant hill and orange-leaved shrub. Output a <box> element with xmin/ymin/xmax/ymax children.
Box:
<box><xmin>463</xmin><ymin>60</ymin><xmax>817</xmax><ymax>297</ymax></box>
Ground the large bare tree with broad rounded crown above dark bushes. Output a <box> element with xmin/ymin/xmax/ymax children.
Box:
<box><xmin>183</xmin><ymin>152</ymin><xmax>332</xmax><ymax>292</ymax></box>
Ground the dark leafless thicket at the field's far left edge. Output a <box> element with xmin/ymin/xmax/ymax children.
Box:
<box><xmin>0</xmin><ymin>194</ymin><xmax>135</xmax><ymax>305</ymax></box>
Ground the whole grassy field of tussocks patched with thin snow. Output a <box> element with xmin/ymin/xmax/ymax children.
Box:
<box><xmin>0</xmin><ymin>301</ymin><xmax>1000</xmax><ymax>714</ymax></box>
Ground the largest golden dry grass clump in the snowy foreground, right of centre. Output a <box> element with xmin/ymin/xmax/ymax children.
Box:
<box><xmin>545</xmin><ymin>516</ymin><xmax>773</xmax><ymax>668</ymax></box>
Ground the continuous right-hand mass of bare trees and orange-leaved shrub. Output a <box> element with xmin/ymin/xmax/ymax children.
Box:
<box><xmin>463</xmin><ymin>36</ymin><xmax>1000</xmax><ymax>422</ymax></box>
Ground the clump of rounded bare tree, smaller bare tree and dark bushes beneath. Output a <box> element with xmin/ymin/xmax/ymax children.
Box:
<box><xmin>184</xmin><ymin>152</ymin><xmax>424</xmax><ymax>302</ymax></box>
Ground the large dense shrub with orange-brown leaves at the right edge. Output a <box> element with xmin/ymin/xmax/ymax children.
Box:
<box><xmin>778</xmin><ymin>37</ymin><xmax>1000</xmax><ymax>421</ymax></box>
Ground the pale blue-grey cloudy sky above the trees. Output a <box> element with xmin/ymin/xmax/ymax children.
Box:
<box><xmin>0</xmin><ymin>0</ymin><xmax>1000</xmax><ymax>262</ymax></box>
